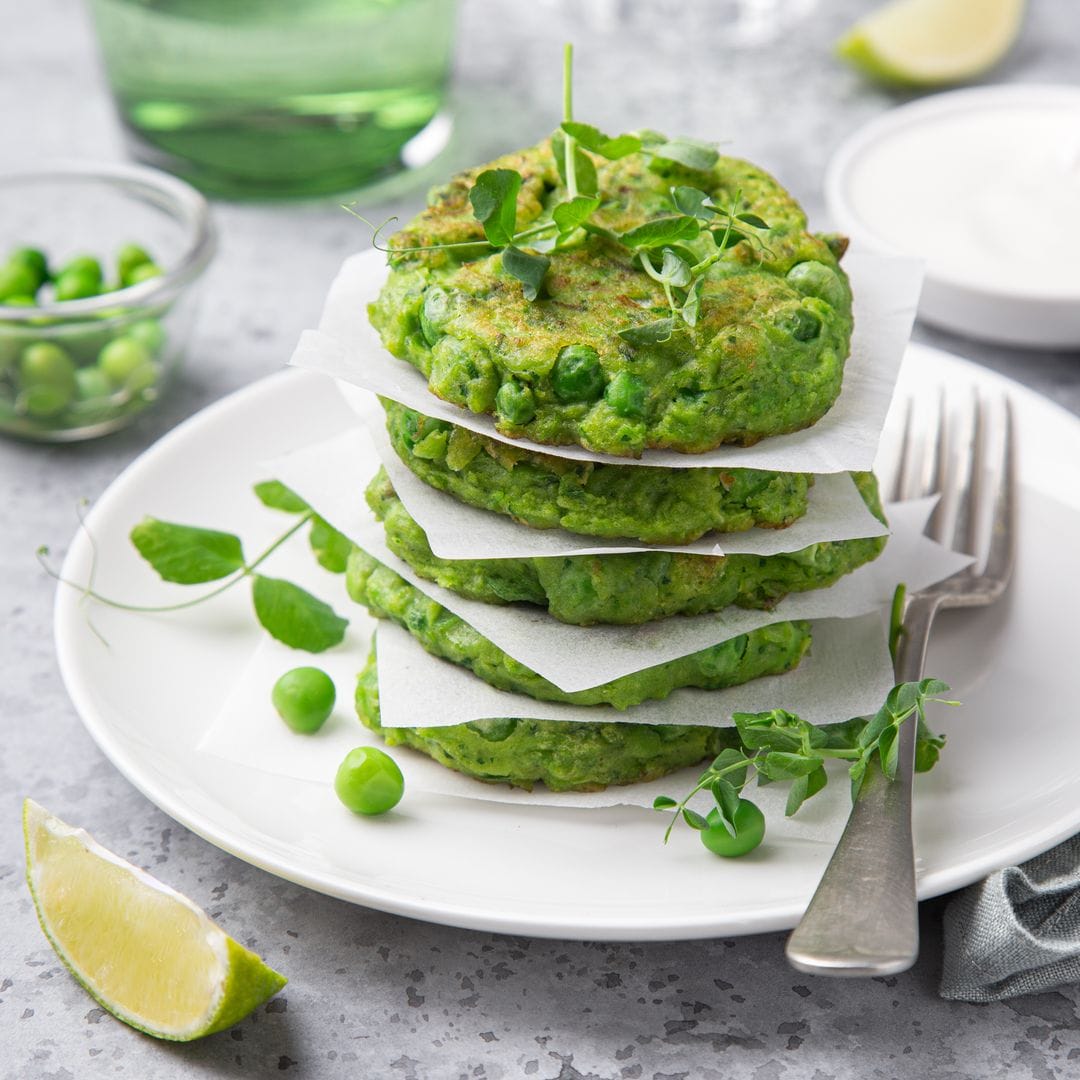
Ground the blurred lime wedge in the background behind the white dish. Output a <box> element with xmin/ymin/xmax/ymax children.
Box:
<box><xmin>837</xmin><ymin>0</ymin><xmax>1024</xmax><ymax>86</ymax></box>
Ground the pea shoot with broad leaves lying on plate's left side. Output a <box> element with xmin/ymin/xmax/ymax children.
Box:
<box><xmin>37</xmin><ymin>481</ymin><xmax>352</xmax><ymax>652</ymax></box>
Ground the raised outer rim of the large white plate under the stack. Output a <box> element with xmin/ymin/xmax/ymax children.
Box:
<box><xmin>53</xmin><ymin>342</ymin><xmax>1080</xmax><ymax>942</ymax></box>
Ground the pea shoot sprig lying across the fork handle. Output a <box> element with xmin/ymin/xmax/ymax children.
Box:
<box><xmin>652</xmin><ymin>678</ymin><xmax>958</xmax><ymax>854</ymax></box>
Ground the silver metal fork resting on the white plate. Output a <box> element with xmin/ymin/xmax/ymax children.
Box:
<box><xmin>787</xmin><ymin>393</ymin><xmax>1016</xmax><ymax>976</ymax></box>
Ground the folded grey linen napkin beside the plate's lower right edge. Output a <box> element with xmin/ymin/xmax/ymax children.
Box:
<box><xmin>941</xmin><ymin>835</ymin><xmax>1080</xmax><ymax>1001</ymax></box>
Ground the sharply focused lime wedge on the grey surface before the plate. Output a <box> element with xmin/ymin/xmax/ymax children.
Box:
<box><xmin>23</xmin><ymin>799</ymin><xmax>285</xmax><ymax>1041</ymax></box>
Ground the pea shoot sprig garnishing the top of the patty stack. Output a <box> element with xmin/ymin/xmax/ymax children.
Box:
<box><xmin>345</xmin><ymin>44</ymin><xmax>769</xmax><ymax>336</ymax></box>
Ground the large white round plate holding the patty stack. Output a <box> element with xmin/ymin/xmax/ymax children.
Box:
<box><xmin>56</xmin><ymin>347</ymin><xmax>1080</xmax><ymax>941</ymax></box>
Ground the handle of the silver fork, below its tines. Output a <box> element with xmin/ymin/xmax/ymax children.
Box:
<box><xmin>787</xmin><ymin>596</ymin><xmax>937</xmax><ymax>977</ymax></box>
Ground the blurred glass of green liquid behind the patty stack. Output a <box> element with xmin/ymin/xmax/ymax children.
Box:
<box><xmin>86</xmin><ymin>0</ymin><xmax>455</xmax><ymax>198</ymax></box>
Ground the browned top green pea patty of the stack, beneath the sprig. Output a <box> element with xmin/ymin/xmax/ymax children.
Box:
<box><xmin>368</xmin><ymin>141</ymin><xmax>852</xmax><ymax>457</ymax></box>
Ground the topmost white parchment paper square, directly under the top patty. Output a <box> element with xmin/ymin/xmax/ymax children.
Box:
<box><xmin>291</xmin><ymin>249</ymin><xmax>922</xmax><ymax>473</ymax></box>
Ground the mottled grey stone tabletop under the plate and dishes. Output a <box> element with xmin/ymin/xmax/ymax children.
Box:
<box><xmin>0</xmin><ymin>0</ymin><xmax>1080</xmax><ymax>1080</ymax></box>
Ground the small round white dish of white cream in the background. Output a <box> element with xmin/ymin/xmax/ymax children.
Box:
<box><xmin>825</xmin><ymin>85</ymin><xmax>1080</xmax><ymax>349</ymax></box>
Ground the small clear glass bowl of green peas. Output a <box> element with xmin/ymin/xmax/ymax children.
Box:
<box><xmin>0</xmin><ymin>163</ymin><xmax>215</xmax><ymax>442</ymax></box>
